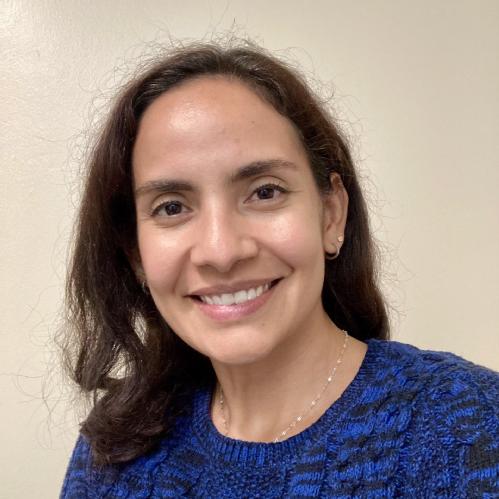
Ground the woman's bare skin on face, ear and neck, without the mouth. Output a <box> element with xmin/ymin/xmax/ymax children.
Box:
<box><xmin>132</xmin><ymin>77</ymin><xmax>366</xmax><ymax>442</ymax></box>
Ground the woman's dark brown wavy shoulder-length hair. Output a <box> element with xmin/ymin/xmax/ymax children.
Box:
<box><xmin>64</xmin><ymin>44</ymin><xmax>389</xmax><ymax>464</ymax></box>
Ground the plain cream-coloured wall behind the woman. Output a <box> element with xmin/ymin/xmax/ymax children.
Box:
<box><xmin>0</xmin><ymin>0</ymin><xmax>499</xmax><ymax>499</ymax></box>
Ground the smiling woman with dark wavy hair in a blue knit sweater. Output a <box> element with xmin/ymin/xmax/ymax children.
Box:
<box><xmin>62</xmin><ymin>45</ymin><xmax>499</xmax><ymax>498</ymax></box>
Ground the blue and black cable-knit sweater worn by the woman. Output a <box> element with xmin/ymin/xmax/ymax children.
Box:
<box><xmin>61</xmin><ymin>340</ymin><xmax>499</xmax><ymax>499</ymax></box>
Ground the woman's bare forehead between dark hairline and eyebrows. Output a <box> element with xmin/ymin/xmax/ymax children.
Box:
<box><xmin>133</xmin><ymin>76</ymin><xmax>307</xmax><ymax>183</ymax></box>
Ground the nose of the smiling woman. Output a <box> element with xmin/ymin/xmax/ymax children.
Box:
<box><xmin>191</xmin><ymin>206</ymin><xmax>258</xmax><ymax>273</ymax></box>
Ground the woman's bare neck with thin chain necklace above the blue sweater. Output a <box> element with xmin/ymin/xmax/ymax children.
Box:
<box><xmin>212</xmin><ymin>313</ymin><xmax>345</xmax><ymax>442</ymax></box>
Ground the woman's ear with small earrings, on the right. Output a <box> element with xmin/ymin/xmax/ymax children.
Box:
<box><xmin>322</xmin><ymin>173</ymin><xmax>348</xmax><ymax>253</ymax></box>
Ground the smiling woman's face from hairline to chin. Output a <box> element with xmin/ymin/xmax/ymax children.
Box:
<box><xmin>133</xmin><ymin>77</ymin><xmax>341</xmax><ymax>365</ymax></box>
